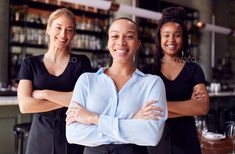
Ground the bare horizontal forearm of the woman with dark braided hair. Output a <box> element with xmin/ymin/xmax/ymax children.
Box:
<box><xmin>167</xmin><ymin>99</ymin><xmax>209</xmax><ymax>116</ymax></box>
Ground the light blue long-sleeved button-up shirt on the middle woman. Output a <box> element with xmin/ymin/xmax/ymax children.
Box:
<box><xmin>66</xmin><ymin>68</ymin><xmax>167</xmax><ymax>146</ymax></box>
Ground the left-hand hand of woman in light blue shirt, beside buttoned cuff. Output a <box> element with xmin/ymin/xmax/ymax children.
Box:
<box><xmin>66</xmin><ymin>103</ymin><xmax>99</xmax><ymax>125</ymax></box>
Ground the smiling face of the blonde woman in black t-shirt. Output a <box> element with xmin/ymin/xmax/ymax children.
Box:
<box><xmin>47</xmin><ymin>15</ymin><xmax>75</xmax><ymax>49</ymax></box>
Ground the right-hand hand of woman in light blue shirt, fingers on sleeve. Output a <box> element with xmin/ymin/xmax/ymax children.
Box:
<box><xmin>132</xmin><ymin>100</ymin><xmax>162</xmax><ymax>120</ymax></box>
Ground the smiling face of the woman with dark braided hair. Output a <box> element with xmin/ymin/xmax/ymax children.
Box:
<box><xmin>160</xmin><ymin>22</ymin><xmax>183</xmax><ymax>57</ymax></box>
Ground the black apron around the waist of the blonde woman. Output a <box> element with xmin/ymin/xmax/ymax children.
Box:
<box><xmin>26</xmin><ymin>108</ymin><xmax>83</xmax><ymax>154</ymax></box>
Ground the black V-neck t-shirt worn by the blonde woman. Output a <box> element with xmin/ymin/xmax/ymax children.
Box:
<box><xmin>17</xmin><ymin>54</ymin><xmax>91</xmax><ymax>92</ymax></box>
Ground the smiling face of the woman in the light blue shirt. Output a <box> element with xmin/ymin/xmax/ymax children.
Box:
<box><xmin>108</xmin><ymin>19</ymin><xmax>140</xmax><ymax>63</ymax></box>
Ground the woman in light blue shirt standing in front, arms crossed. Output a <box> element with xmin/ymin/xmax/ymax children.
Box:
<box><xmin>66</xmin><ymin>18</ymin><xmax>167</xmax><ymax>154</ymax></box>
